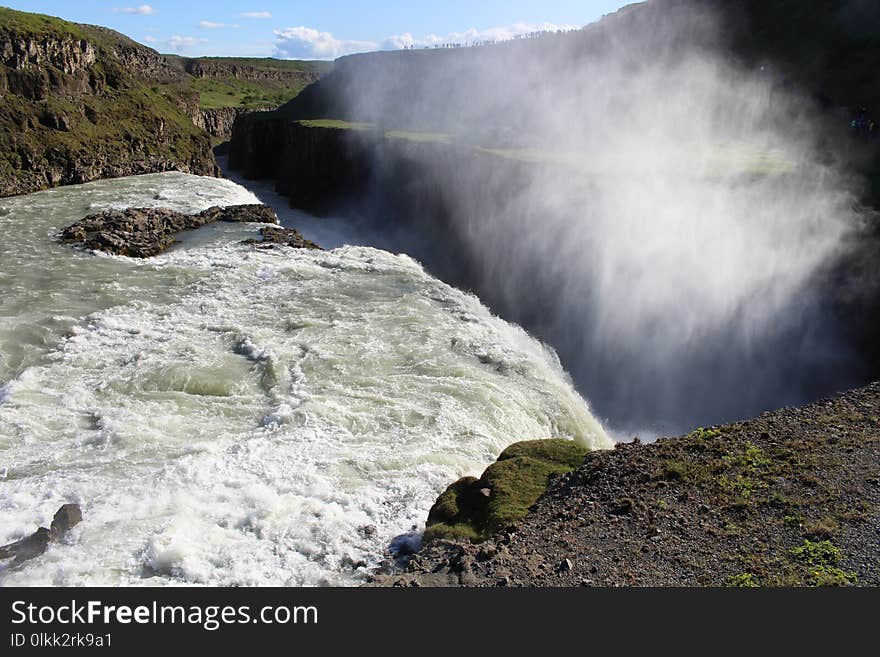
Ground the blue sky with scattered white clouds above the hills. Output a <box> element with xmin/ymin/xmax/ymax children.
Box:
<box><xmin>0</xmin><ymin>0</ymin><xmax>629</xmax><ymax>59</ymax></box>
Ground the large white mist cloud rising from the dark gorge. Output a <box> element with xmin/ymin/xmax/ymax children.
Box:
<box><xmin>294</xmin><ymin>1</ymin><xmax>863</xmax><ymax>436</ymax></box>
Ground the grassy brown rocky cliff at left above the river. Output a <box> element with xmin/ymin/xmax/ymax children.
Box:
<box><xmin>0</xmin><ymin>9</ymin><xmax>219</xmax><ymax>196</ymax></box>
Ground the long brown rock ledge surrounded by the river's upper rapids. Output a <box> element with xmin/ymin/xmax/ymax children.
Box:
<box><xmin>61</xmin><ymin>204</ymin><xmax>282</xmax><ymax>258</ymax></box>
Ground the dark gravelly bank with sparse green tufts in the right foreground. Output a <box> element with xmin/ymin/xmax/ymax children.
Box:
<box><xmin>374</xmin><ymin>383</ymin><xmax>880</xmax><ymax>586</ymax></box>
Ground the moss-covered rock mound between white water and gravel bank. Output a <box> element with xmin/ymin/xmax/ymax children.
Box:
<box><xmin>425</xmin><ymin>439</ymin><xmax>589</xmax><ymax>542</ymax></box>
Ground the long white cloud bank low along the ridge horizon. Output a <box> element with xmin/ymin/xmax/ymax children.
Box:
<box><xmin>275</xmin><ymin>23</ymin><xmax>577</xmax><ymax>59</ymax></box>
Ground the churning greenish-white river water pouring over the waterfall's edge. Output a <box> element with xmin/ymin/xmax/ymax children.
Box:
<box><xmin>0</xmin><ymin>173</ymin><xmax>608</xmax><ymax>585</ymax></box>
